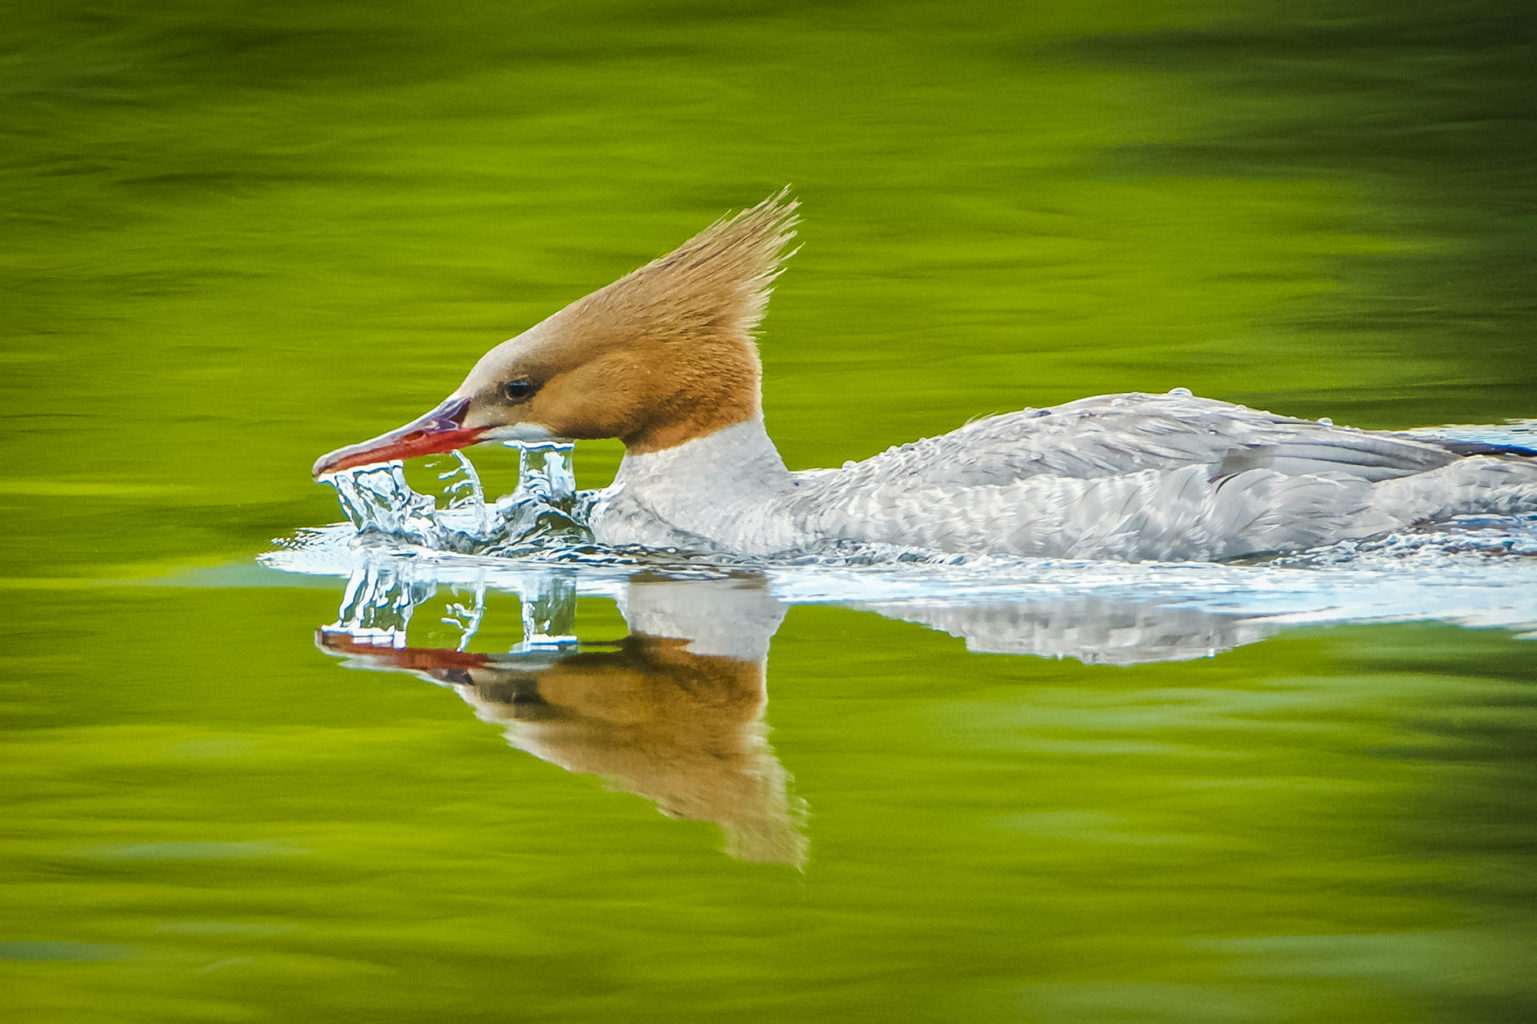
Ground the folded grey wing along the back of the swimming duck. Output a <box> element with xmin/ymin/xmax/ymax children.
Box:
<box><xmin>805</xmin><ymin>394</ymin><xmax>1459</xmax><ymax>487</ymax></box>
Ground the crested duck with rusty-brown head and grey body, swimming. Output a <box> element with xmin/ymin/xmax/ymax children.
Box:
<box><xmin>312</xmin><ymin>189</ymin><xmax>1537</xmax><ymax>561</ymax></box>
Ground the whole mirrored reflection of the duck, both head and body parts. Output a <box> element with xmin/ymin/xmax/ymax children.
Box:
<box><xmin>318</xmin><ymin>560</ymin><xmax>1277</xmax><ymax>866</ymax></box>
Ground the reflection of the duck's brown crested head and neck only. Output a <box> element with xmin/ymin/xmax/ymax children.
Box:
<box><xmin>317</xmin><ymin>572</ymin><xmax>807</xmax><ymax>867</ymax></box>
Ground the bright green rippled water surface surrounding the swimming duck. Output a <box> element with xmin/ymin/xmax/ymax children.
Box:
<box><xmin>0</xmin><ymin>0</ymin><xmax>1537</xmax><ymax>1022</ymax></box>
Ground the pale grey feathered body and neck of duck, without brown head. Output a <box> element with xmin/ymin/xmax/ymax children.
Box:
<box><xmin>595</xmin><ymin>394</ymin><xmax>1537</xmax><ymax>561</ymax></box>
